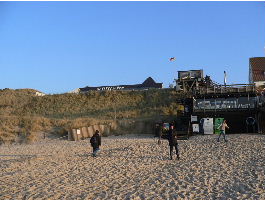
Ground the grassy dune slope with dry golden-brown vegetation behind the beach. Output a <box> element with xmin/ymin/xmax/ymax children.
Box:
<box><xmin>0</xmin><ymin>89</ymin><xmax>177</xmax><ymax>142</ymax></box>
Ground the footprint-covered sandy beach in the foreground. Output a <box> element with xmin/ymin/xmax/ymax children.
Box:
<box><xmin>0</xmin><ymin>134</ymin><xmax>265</xmax><ymax>199</ymax></box>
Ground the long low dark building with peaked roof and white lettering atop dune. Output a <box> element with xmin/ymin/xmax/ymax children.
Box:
<box><xmin>79</xmin><ymin>77</ymin><xmax>163</xmax><ymax>93</ymax></box>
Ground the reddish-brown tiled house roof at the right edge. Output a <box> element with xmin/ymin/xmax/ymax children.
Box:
<box><xmin>249</xmin><ymin>57</ymin><xmax>265</xmax><ymax>82</ymax></box>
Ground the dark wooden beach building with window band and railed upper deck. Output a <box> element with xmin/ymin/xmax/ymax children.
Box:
<box><xmin>176</xmin><ymin>69</ymin><xmax>265</xmax><ymax>133</ymax></box>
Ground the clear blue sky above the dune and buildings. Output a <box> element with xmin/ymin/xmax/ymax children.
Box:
<box><xmin>0</xmin><ymin>2</ymin><xmax>265</xmax><ymax>94</ymax></box>
